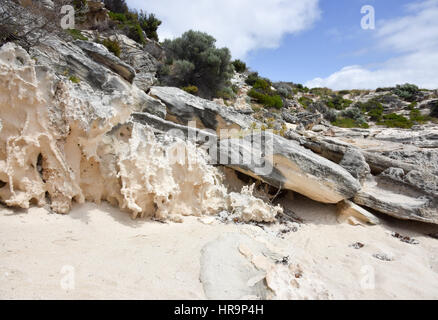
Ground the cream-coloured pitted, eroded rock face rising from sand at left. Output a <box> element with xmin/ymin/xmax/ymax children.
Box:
<box><xmin>0</xmin><ymin>43</ymin><xmax>276</xmax><ymax>221</ymax></box>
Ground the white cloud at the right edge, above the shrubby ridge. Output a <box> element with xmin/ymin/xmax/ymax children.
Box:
<box><xmin>306</xmin><ymin>0</ymin><xmax>438</xmax><ymax>89</ymax></box>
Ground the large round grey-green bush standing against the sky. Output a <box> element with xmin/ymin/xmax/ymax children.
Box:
<box><xmin>162</xmin><ymin>30</ymin><xmax>232</xmax><ymax>98</ymax></box>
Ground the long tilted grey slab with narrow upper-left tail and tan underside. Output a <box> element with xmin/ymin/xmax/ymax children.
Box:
<box><xmin>132</xmin><ymin>113</ymin><xmax>361</xmax><ymax>203</ymax></box>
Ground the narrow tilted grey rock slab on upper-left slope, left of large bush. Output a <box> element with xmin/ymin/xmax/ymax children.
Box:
<box><xmin>74</xmin><ymin>40</ymin><xmax>135</xmax><ymax>83</ymax></box>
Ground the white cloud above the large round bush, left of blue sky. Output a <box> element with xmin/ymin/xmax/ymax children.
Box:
<box><xmin>127</xmin><ymin>0</ymin><xmax>320</xmax><ymax>58</ymax></box>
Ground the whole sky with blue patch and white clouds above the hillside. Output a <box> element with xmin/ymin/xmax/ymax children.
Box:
<box><xmin>127</xmin><ymin>0</ymin><xmax>438</xmax><ymax>90</ymax></box>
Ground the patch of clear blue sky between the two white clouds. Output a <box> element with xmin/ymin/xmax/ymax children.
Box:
<box><xmin>246</xmin><ymin>0</ymin><xmax>409</xmax><ymax>83</ymax></box>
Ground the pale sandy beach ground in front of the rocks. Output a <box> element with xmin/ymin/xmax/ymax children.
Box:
<box><xmin>0</xmin><ymin>196</ymin><xmax>438</xmax><ymax>299</ymax></box>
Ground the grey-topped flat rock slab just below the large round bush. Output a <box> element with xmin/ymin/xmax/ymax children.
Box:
<box><xmin>149</xmin><ymin>87</ymin><xmax>254</xmax><ymax>134</ymax></box>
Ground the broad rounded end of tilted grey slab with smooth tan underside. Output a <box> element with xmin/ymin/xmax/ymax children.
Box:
<box><xmin>219</xmin><ymin>132</ymin><xmax>360</xmax><ymax>203</ymax></box>
